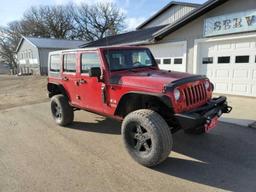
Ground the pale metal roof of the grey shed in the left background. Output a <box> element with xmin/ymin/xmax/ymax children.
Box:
<box><xmin>16</xmin><ymin>37</ymin><xmax>86</xmax><ymax>52</ymax></box>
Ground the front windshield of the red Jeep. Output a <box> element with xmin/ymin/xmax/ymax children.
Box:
<box><xmin>105</xmin><ymin>49</ymin><xmax>156</xmax><ymax>71</ymax></box>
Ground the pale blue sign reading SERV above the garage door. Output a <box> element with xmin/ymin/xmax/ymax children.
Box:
<box><xmin>204</xmin><ymin>10</ymin><xmax>256</xmax><ymax>37</ymax></box>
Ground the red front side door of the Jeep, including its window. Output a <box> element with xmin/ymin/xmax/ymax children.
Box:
<box><xmin>77</xmin><ymin>51</ymin><xmax>104</xmax><ymax>112</ymax></box>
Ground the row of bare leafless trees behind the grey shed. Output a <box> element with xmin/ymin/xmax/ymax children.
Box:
<box><xmin>0</xmin><ymin>3</ymin><xmax>125</xmax><ymax>71</ymax></box>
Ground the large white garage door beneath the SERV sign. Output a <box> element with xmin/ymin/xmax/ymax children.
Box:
<box><xmin>198</xmin><ymin>38</ymin><xmax>256</xmax><ymax>97</ymax></box>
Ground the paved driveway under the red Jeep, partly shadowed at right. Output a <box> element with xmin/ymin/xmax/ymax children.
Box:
<box><xmin>0</xmin><ymin>103</ymin><xmax>256</xmax><ymax>192</ymax></box>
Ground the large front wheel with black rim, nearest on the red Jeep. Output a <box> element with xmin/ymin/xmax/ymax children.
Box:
<box><xmin>122</xmin><ymin>109</ymin><xmax>173</xmax><ymax>167</ymax></box>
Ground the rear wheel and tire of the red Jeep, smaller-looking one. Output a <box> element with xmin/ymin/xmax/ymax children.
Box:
<box><xmin>51</xmin><ymin>95</ymin><xmax>74</xmax><ymax>126</ymax></box>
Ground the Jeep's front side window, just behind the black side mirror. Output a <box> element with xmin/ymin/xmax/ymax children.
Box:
<box><xmin>81</xmin><ymin>53</ymin><xmax>100</xmax><ymax>73</ymax></box>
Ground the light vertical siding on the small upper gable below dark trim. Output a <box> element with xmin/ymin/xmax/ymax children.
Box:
<box><xmin>143</xmin><ymin>5</ymin><xmax>195</xmax><ymax>29</ymax></box>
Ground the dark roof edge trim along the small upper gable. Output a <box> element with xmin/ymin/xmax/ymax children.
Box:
<box><xmin>136</xmin><ymin>1</ymin><xmax>201</xmax><ymax>29</ymax></box>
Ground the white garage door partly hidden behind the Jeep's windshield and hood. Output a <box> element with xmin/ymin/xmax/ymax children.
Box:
<box><xmin>148</xmin><ymin>41</ymin><xmax>187</xmax><ymax>72</ymax></box>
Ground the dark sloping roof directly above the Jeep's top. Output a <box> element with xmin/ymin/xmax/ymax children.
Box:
<box><xmin>80</xmin><ymin>25</ymin><xmax>166</xmax><ymax>47</ymax></box>
